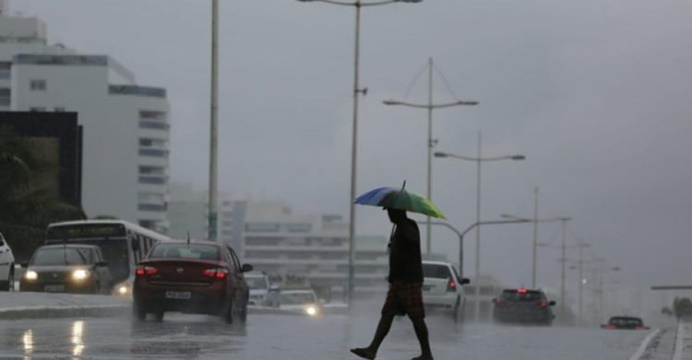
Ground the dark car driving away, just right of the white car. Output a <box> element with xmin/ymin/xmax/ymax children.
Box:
<box><xmin>493</xmin><ymin>288</ymin><xmax>555</xmax><ymax>325</ymax></box>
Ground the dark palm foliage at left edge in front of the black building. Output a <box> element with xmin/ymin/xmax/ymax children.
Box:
<box><xmin>0</xmin><ymin>128</ymin><xmax>86</xmax><ymax>262</ymax></box>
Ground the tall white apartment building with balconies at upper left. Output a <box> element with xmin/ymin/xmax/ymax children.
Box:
<box><xmin>0</xmin><ymin>4</ymin><xmax>170</xmax><ymax>232</ymax></box>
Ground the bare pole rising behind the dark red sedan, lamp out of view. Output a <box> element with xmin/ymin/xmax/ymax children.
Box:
<box><xmin>207</xmin><ymin>0</ymin><xmax>219</xmax><ymax>241</ymax></box>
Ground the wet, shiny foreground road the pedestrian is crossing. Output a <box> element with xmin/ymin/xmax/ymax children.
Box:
<box><xmin>0</xmin><ymin>314</ymin><xmax>648</xmax><ymax>360</ymax></box>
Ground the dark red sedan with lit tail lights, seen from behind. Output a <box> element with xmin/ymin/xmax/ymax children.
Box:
<box><xmin>133</xmin><ymin>241</ymin><xmax>252</xmax><ymax>323</ymax></box>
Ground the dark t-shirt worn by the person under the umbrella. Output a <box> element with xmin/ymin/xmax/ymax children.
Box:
<box><xmin>389</xmin><ymin>219</ymin><xmax>423</xmax><ymax>284</ymax></box>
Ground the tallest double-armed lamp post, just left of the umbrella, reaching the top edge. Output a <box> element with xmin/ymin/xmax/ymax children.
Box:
<box><xmin>298</xmin><ymin>0</ymin><xmax>423</xmax><ymax>304</ymax></box>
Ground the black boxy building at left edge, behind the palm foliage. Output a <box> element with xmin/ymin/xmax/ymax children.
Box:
<box><xmin>0</xmin><ymin>111</ymin><xmax>82</xmax><ymax>207</ymax></box>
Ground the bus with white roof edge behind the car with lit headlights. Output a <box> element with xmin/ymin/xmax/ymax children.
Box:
<box><xmin>45</xmin><ymin>220</ymin><xmax>170</xmax><ymax>297</ymax></box>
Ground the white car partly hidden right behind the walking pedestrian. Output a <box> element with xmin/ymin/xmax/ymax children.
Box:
<box><xmin>423</xmin><ymin>261</ymin><xmax>469</xmax><ymax>321</ymax></box>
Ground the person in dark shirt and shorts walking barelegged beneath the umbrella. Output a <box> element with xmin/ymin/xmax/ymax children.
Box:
<box><xmin>351</xmin><ymin>208</ymin><xmax>433</xmax><ymax>360</ymax></box>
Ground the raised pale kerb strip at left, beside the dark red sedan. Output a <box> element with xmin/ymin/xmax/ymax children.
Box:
<box><xmin>0</xmin><ymin>292</ymin><xmax>132</xmax><ymax>319</ymax></box>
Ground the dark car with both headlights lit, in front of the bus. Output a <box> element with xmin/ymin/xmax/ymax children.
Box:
<box><xmin>20</xmin><ymin>244</ymin><xmax>113</xmax><ymax>294</ymax></box>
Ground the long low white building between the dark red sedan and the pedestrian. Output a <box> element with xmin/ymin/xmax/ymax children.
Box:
<box><xmin>242</xmin><ymin>202</ymin><xmax>389</xmax><ymax>298</ymax></box>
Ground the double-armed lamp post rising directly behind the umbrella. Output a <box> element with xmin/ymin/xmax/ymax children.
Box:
<box><xmin>383</xmin><ymin>58</ymin><xmax>478</xmax><ymax>256</ymax></box>
